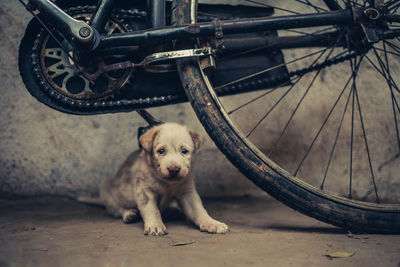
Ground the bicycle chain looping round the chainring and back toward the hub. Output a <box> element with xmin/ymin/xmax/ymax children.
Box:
<box><xmin>31</xmin><ymin>6</ymin><xmax>359</xmax><ymax>108</ymax></box>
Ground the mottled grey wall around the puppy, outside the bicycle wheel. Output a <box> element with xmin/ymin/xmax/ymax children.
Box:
<box><xmin>0</xmin><ymin>0</ymin><xmax>262</xmax><ymax>197</ymax></box>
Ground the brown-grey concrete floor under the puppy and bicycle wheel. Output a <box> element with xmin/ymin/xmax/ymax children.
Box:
<box><xmin>0</xmin><ymin>198</ymin><xmax>400</xmax><ymax>267</ymax></box>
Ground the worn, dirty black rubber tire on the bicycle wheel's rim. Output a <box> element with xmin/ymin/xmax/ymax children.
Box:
<box><xmin>172</xmin><ymin>0</ymin><xmax>400</xmax><ymax>234</ymax></box>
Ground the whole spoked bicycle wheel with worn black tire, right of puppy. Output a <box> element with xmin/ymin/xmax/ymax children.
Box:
<box><xmin>172</xmin><ymin>0</ymin><xmax>400</xmax><ymax>233</ymax></box>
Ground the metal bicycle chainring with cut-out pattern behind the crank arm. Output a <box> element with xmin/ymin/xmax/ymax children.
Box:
<box><xmin>35</xmin><ymin>11</ymin><xmax>132</xmax><ymax>100</ymax></box>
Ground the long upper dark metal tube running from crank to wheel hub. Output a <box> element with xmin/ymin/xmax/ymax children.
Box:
<box><xmin>99</xmin><ymin>9</ymin><xmax>354</xmax><ymax>48</ymax></box>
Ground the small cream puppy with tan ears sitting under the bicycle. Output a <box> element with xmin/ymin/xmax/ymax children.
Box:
<box><xmin>100</xmin><ymin>123</ymin><xmax>228</xmax><ymax>236</ymax></box>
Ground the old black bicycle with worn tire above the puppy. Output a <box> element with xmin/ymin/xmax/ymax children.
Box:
<box><xmin>19</xmin><ymin>0</ymin><xmax>400</xmax><ymax>233</ymax></box>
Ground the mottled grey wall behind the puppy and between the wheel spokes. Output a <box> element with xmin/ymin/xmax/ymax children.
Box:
<box><xmin>0</xmin><ymin>0</ymin><xmax>400</xmax><ymax>199</ymax></box>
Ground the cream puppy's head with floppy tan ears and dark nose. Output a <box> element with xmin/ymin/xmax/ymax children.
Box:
<box><xmin>139</xmin><ymin>123</ymin><xmax>200</xmax><ymax>181</ymax></box>
